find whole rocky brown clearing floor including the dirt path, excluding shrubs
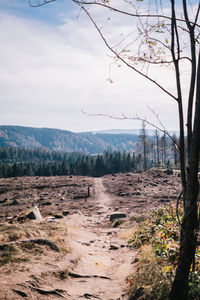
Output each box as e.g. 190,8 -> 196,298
0,170 -> 180,300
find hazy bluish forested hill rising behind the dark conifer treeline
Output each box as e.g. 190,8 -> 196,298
0,125 -> 138,154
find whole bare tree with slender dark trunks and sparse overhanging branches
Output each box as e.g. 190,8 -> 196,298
28,0 -> 200,300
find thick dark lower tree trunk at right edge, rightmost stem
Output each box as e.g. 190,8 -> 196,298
170,49 -> 200,300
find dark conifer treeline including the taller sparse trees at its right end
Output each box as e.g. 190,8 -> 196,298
0,123 -> 179,177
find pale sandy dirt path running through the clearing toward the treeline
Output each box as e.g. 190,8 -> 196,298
62,178 -> 134,300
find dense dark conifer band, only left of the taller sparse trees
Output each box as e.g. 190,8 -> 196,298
0,147 -> 143,177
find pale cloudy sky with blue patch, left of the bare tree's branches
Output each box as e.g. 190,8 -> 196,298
0,0 -> 197,132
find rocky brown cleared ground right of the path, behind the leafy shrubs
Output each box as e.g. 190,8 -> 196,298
104,168 -> 181,214
